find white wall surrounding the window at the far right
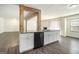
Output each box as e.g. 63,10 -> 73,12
61,15 -> 79,38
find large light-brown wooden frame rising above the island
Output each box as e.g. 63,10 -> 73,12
19,5 -> 41,32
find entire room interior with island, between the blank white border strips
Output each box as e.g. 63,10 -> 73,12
0,4 -> 79,54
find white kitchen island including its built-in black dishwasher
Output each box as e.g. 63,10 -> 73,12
19,30 -> 59,53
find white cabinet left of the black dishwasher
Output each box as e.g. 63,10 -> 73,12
19,33 -> 34,52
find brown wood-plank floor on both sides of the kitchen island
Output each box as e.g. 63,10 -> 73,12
0,32 -> 79,54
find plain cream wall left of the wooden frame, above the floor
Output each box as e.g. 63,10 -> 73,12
0,18 -> 19,33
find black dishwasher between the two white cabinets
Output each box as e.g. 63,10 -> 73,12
34,32 -> 44,49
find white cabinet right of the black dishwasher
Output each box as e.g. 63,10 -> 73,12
44,31 -> 58,45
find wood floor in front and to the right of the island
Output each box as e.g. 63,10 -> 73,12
21,37 -> 79,54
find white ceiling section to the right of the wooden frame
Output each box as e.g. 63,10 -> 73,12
26,4 -> 79,19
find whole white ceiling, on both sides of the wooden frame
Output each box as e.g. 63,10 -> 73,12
0,4 -> 79,20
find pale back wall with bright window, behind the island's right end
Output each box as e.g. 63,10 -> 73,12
41,19 -> 60,30
